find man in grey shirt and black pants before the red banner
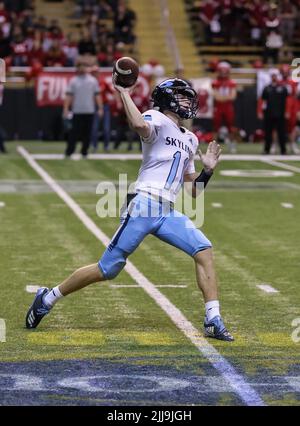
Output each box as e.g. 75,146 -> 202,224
63,61 -> 103,157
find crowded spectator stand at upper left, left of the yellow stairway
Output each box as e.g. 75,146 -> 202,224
0,0 -> 136,71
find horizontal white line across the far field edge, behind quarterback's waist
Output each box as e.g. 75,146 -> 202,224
31,154 -> 300,161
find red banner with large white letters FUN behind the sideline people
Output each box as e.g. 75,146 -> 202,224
35,71 -> 150,107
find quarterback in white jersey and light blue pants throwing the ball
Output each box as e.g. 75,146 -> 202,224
26,78 -> 233,341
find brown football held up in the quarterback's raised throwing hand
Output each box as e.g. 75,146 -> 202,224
113,56 -> 139,87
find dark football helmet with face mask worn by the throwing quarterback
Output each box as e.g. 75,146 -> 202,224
152,78 -> 198,119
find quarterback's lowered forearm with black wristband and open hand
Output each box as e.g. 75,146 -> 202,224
184,141 -> 222,198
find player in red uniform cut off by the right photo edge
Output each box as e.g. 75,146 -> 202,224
280,64 -> 300,154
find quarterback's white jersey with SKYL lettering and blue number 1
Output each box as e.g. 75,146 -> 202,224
135,109 -> 198,202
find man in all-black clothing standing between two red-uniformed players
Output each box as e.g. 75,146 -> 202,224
262,70 -> 288,155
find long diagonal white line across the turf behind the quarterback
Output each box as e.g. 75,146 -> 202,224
18,146 -> 265,406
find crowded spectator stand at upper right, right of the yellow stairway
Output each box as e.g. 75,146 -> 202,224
185,0 -> 300,75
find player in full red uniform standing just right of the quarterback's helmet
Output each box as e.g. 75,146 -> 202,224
212,62 -> 236,152
